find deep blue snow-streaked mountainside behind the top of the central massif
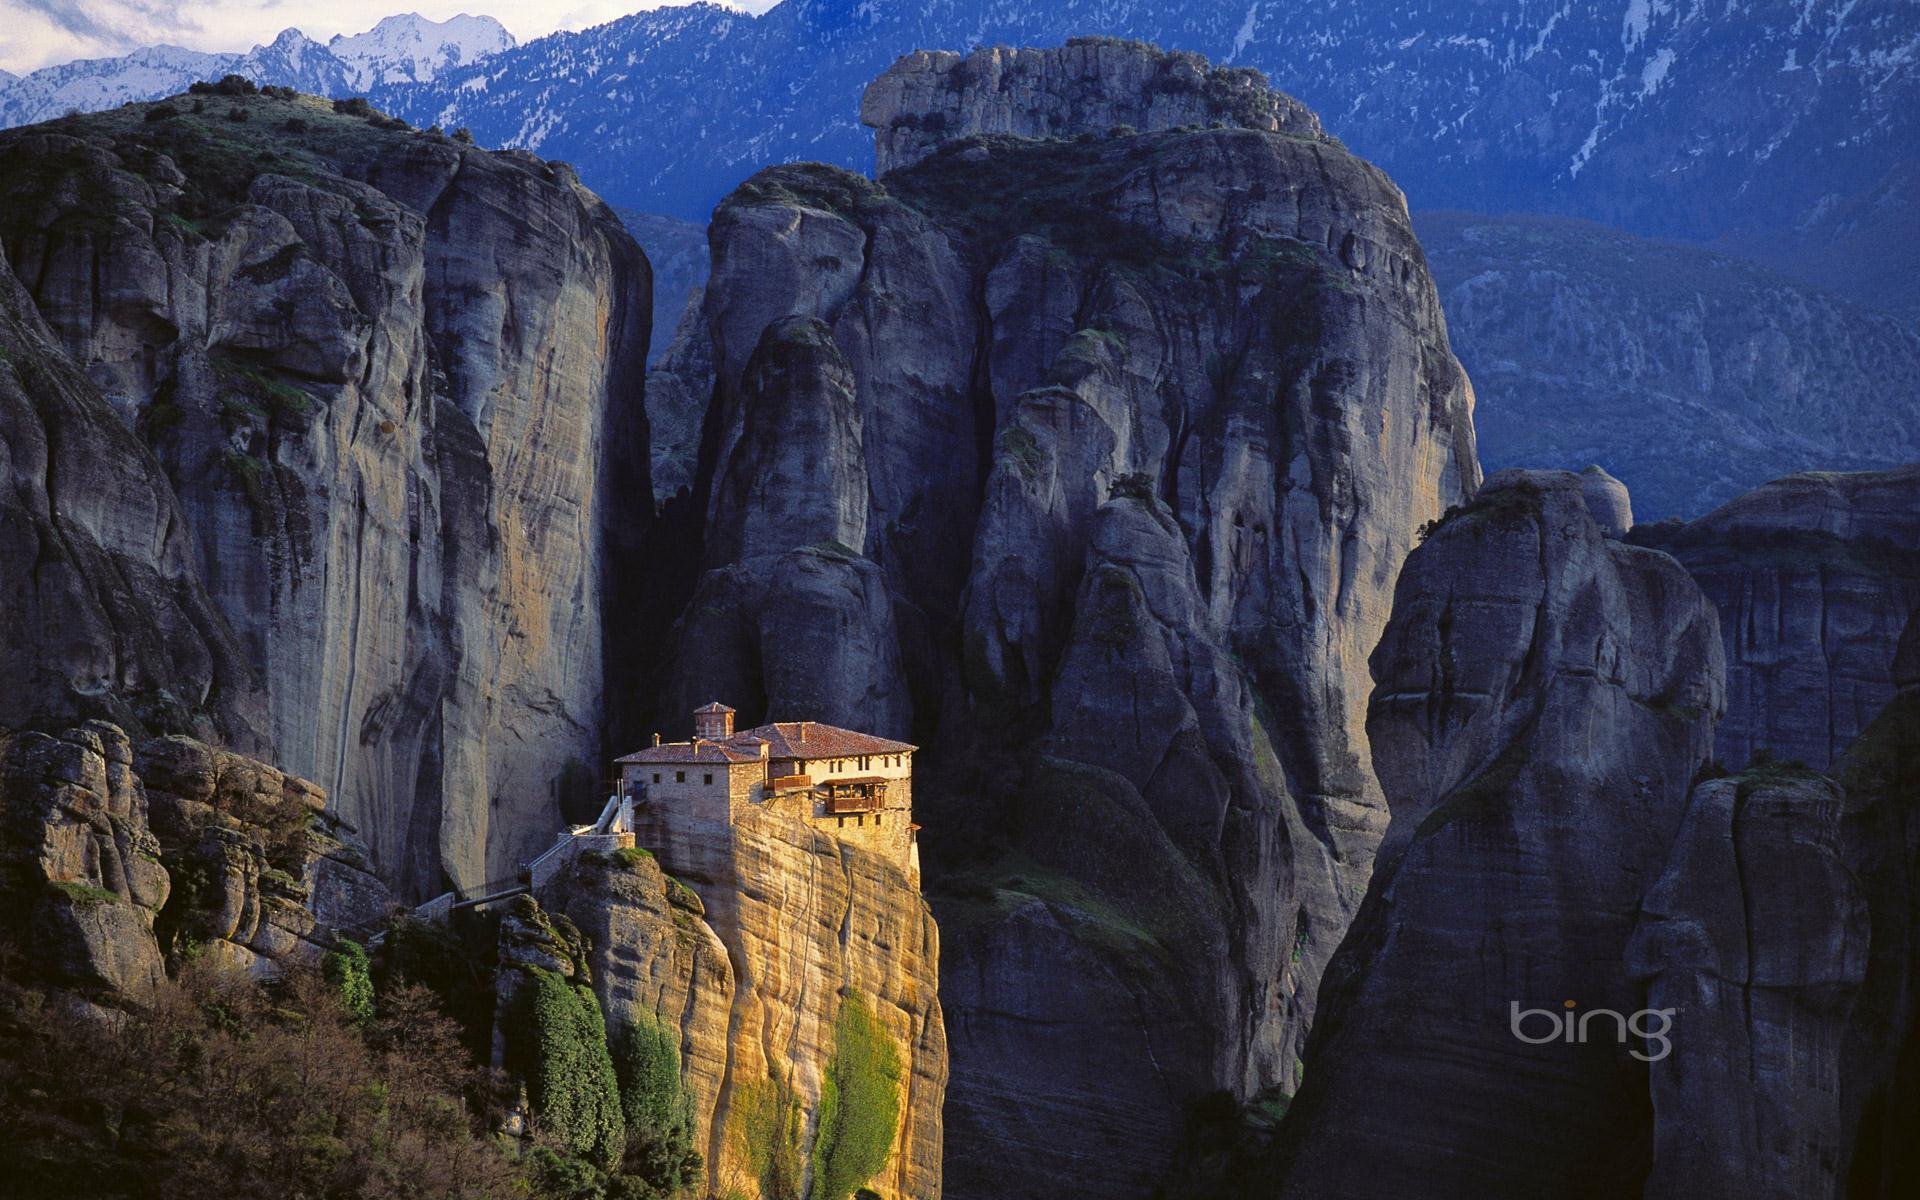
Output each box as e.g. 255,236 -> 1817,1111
376,0 -> 1920,253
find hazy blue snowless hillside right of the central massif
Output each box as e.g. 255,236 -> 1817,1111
1415,213 -> 1920,520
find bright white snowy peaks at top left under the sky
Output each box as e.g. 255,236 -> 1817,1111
0,13 -> 515,127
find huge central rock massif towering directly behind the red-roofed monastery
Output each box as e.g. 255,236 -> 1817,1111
634,42 -> 1478,1196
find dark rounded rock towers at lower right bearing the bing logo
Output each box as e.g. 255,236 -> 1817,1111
1263,472 -> 1920,1196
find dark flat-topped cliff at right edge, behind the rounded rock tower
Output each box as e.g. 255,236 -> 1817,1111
1634,467 -> 1920,770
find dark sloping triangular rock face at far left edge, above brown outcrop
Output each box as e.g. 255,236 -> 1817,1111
0,229 -> 267,747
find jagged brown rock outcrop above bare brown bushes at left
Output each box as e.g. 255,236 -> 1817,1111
0,720 -> 388,1006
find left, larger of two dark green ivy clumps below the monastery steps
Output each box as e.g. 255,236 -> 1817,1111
509,968 -> 626,1167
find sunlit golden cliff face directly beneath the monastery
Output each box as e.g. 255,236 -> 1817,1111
537,798 -> 947,1198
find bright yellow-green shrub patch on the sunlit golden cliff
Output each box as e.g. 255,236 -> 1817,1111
812,993 -> 900,1200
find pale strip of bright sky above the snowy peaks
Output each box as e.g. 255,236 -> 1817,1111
0,0 -> 776,75
